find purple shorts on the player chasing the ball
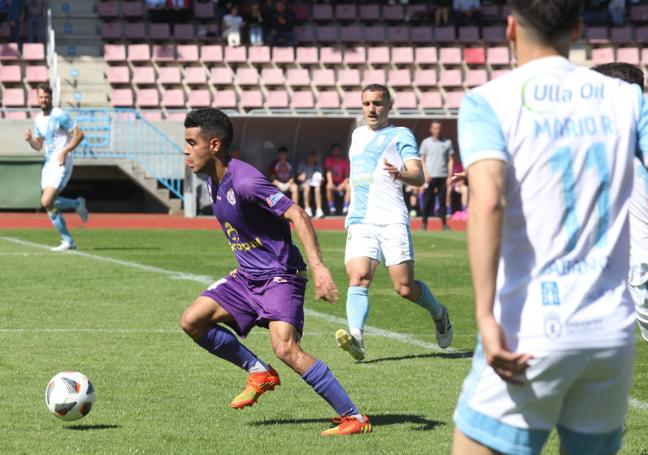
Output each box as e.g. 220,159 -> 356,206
201,272 -> 308,337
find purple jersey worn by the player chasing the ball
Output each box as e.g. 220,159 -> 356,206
207,159 -> 306,276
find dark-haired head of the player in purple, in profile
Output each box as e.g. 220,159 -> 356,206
184,107 -> 234,175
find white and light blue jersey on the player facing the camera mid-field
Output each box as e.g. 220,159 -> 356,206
346,125 -> 420,227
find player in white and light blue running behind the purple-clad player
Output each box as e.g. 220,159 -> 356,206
335,84 -> 452,360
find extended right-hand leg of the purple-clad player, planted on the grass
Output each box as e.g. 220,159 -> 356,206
269,321 -> 371,436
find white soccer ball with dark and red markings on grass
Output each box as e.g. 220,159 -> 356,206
45,371 -> 97,420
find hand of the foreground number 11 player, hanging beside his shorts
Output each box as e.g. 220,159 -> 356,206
479,317 -> 533,384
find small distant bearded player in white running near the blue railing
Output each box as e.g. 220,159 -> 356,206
25,84 -> 88,251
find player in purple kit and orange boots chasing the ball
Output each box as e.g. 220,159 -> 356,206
180,108 -> 371,436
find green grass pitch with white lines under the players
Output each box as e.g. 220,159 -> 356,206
0,229 -> 648,455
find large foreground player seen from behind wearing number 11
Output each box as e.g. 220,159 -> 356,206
452,0 -> 648,455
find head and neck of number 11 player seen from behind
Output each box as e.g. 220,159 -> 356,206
506,0 -> 584,63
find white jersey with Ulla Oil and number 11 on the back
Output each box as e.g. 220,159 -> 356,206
459,56 -> 648,355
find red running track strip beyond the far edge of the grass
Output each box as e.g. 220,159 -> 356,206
0,213 -> 466,231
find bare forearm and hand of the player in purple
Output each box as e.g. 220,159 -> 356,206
284,204 -> 338,303
